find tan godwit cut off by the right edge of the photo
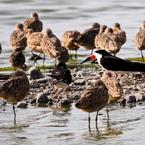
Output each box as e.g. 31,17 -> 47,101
135,22 -> 145,61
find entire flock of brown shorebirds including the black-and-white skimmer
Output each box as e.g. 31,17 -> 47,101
0,12 -> 145,130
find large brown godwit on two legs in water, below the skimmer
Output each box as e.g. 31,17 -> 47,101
75,80 -> 109,132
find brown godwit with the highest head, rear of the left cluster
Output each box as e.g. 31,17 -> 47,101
23,12 -> 43,33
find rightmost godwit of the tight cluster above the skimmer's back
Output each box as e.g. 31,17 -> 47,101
113,23 -> 127,46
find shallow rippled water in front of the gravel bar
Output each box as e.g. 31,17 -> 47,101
0,105 -> 145,145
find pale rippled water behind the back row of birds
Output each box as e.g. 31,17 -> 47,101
0,0 -> 145,66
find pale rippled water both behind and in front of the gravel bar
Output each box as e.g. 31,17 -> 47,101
0,0 -> 145,145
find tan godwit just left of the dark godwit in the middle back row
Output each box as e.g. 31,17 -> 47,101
62,31 -> 80,59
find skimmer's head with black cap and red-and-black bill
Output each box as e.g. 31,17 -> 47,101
80,50 -> 111,64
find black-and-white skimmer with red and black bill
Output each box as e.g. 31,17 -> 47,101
80,50 -> 145,72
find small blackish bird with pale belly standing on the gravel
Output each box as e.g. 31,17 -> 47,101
49,62 -> 72,98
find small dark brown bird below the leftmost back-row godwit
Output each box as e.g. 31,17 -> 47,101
10,51 -> 27,70
